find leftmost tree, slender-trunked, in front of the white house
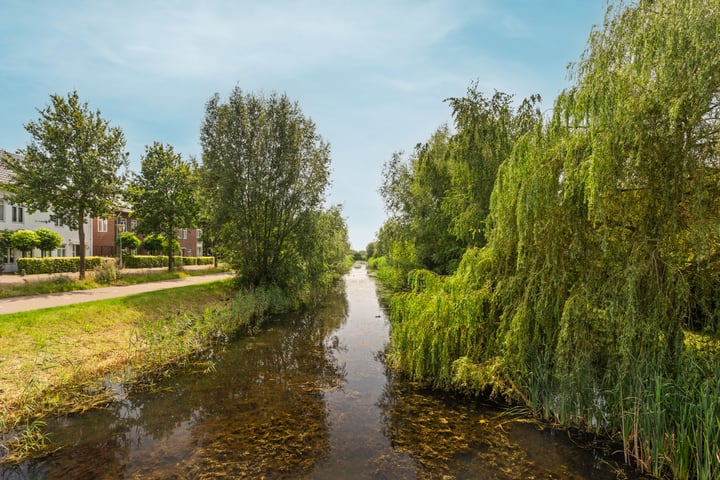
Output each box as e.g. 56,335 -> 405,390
5,91 -> 127,278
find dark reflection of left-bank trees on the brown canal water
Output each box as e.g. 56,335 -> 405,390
35,291 -> 348,478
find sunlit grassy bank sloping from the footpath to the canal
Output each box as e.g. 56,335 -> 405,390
0,281 -> 288,462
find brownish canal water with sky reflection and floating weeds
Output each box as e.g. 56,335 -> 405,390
0,265 -> 640,480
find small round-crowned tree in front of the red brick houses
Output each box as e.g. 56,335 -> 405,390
128,142 -> 199,270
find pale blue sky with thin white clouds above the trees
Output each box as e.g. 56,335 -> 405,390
0,0 -> 606,249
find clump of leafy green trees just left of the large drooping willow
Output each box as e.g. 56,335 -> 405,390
376,87 -> 542,288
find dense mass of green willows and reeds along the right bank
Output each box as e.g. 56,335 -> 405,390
371,0 -> 720,479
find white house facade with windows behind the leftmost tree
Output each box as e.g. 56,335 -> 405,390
0,150 -> 93,273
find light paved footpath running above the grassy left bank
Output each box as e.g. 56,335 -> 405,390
0,273 -> 233,315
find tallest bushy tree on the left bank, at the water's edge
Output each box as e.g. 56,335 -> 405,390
201,88 -> 330,287
